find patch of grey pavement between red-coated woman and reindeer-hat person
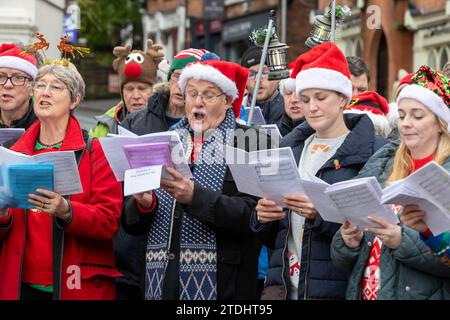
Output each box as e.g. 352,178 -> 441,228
74,99 -> 119,130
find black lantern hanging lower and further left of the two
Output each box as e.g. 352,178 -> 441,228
266,10 -> 290,80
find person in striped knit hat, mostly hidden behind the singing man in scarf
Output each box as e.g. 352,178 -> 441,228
114,48 -> 218,300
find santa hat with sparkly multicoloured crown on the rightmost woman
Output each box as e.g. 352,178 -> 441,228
397,66 -> 450,132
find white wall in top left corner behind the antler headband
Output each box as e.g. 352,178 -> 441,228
0,0 -> 65,59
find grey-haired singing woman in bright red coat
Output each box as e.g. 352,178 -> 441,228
0,64 -> 122,300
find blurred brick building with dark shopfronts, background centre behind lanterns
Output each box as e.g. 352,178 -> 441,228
143,0 -> 317,62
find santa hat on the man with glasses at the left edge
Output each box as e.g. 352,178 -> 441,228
0,43 -> 38,80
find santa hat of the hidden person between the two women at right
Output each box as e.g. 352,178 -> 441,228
344,91 -> 392,137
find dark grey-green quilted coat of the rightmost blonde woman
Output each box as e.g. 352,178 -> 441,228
331,142 -> 450,300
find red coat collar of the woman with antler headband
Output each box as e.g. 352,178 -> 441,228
11,115 -> 86,155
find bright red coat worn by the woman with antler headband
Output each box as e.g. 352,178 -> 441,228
0,117 -> 122,300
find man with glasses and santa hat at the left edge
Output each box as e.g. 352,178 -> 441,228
0,43 -> 37,129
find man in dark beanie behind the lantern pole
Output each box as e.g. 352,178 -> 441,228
241,47 -> 284,124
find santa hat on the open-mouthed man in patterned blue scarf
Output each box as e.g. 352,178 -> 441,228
178,60 -> 248,118
